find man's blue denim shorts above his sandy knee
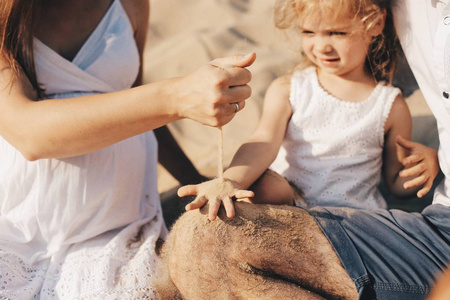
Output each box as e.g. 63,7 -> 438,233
309,204 -> 450,300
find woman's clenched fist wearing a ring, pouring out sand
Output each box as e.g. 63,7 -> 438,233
174,53 -> 256,127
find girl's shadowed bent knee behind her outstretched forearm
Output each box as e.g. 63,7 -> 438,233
250,169 -> 300,205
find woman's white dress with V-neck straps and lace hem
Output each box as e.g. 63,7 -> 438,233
0,0 -> 167,299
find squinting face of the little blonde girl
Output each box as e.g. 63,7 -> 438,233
300,13 -> 371,77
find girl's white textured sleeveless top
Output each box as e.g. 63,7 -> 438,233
271,67 -> 400,209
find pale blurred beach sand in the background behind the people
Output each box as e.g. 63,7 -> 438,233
144,0 -> 438,224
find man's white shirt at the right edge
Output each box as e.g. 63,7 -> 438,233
393,0 -> 450,206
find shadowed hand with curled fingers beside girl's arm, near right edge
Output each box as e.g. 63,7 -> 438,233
396,136 -> 439,198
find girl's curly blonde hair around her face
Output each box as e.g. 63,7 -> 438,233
274,0 -> 400,83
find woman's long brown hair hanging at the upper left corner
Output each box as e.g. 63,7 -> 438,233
0,0 -> 43,98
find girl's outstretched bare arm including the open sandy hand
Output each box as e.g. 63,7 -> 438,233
178,76 -> 292,220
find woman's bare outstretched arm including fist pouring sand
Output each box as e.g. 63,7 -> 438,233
0,54 -> 255,160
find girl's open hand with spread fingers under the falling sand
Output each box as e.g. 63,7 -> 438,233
178,178 -> 254,221
